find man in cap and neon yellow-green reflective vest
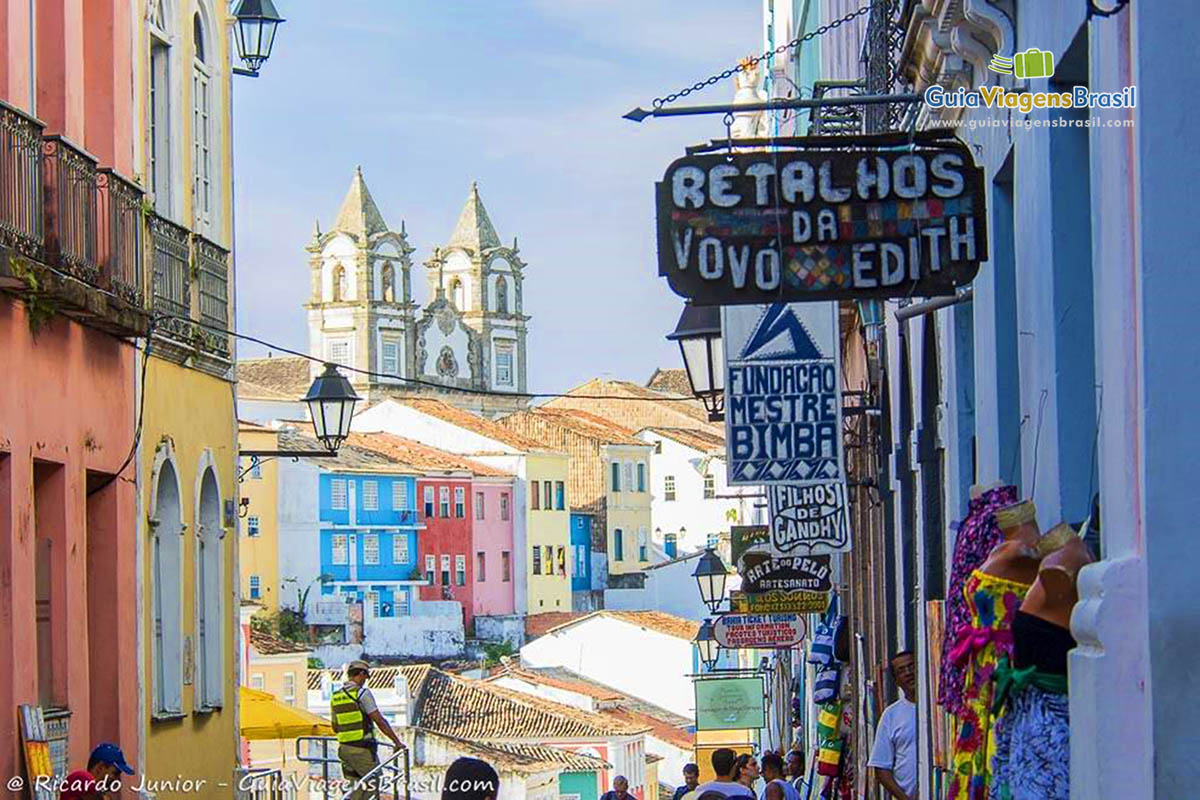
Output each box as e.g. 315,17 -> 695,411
330,661 -> 400,800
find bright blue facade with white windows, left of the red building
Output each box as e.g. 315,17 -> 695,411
318,471 -> 422,616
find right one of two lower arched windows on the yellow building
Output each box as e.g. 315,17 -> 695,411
196,467 -> 224,709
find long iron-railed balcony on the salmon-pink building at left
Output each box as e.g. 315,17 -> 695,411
0,103 -> 150,338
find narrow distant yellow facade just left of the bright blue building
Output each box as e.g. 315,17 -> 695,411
238,423 -> 280,609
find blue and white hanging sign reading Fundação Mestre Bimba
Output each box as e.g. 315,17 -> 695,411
721,302 -> 845,486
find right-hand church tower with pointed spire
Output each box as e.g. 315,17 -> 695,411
418,182 -> 529,400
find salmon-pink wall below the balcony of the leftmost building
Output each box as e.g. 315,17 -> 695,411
0,297 -> 142,775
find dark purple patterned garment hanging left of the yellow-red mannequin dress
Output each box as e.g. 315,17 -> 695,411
937,486 -> 1016,714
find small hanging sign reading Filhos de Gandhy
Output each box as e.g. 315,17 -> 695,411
767,481 -> 850,555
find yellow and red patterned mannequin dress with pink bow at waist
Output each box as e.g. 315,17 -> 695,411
947,570 -> 1030,800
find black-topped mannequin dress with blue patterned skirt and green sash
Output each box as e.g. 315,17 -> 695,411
991,610 -> 1075,800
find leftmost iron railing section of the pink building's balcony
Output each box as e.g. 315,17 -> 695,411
0,101 -> 43,258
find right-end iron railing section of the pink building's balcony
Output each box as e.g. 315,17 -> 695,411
96,169 -> 145,306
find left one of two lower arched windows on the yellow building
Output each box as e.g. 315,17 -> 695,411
150,461 -> 184,716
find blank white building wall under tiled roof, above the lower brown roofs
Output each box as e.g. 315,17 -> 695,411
521,614 -> 695,718
